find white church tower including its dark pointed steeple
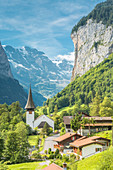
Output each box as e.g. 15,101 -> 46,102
25,85 -> 35,129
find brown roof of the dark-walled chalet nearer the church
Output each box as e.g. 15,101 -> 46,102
54,132 -> 82,142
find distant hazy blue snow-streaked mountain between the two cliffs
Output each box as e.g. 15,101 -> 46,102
3,45 -> 73,104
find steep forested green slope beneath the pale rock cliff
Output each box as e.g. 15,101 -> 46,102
49,54 -> 113,108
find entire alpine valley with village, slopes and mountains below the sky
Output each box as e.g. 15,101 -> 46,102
0,0 -> 113,170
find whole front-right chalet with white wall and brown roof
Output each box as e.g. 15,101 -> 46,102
70,136 -> 110,158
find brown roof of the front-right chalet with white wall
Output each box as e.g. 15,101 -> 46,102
70,136 -> 110,148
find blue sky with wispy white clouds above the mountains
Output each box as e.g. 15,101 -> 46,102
0,0 -> 104,59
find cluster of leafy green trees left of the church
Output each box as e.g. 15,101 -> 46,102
0,102 -> 31,163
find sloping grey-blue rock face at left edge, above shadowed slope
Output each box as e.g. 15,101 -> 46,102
0,43 -> 13,78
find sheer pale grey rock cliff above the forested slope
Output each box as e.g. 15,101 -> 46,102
71,19 -> 113,81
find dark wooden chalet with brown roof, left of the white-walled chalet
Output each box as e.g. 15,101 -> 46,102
54,132 -> 82,153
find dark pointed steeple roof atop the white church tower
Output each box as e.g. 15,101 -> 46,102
25,85 -> 35,109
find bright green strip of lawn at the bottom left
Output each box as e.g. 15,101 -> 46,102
8,162 -> 47,170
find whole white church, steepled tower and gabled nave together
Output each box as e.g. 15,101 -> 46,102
25,86 -> 54,132
